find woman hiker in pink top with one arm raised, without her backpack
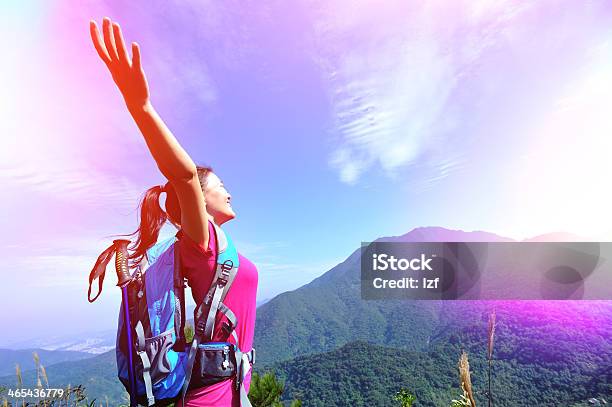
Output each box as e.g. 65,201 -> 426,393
90,18 -> 258,407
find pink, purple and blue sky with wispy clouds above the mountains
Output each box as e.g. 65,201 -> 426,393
0,0 -> 612,340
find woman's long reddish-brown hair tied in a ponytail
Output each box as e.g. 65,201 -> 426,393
127,166 -> 213,268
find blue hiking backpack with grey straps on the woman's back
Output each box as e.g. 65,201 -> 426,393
88,223 -> 255,407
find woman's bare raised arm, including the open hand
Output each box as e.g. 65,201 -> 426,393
90,18 -> 208,247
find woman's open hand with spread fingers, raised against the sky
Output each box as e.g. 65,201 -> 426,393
89,17 -> 149,108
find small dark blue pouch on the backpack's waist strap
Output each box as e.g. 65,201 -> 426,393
190,342 -> 236,387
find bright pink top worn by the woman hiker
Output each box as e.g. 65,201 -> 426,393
176,221 -> 258,407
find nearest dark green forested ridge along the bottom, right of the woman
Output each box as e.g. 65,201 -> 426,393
266,341 -> 612,407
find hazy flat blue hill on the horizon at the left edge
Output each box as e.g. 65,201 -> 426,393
0,349 -> 92,376
